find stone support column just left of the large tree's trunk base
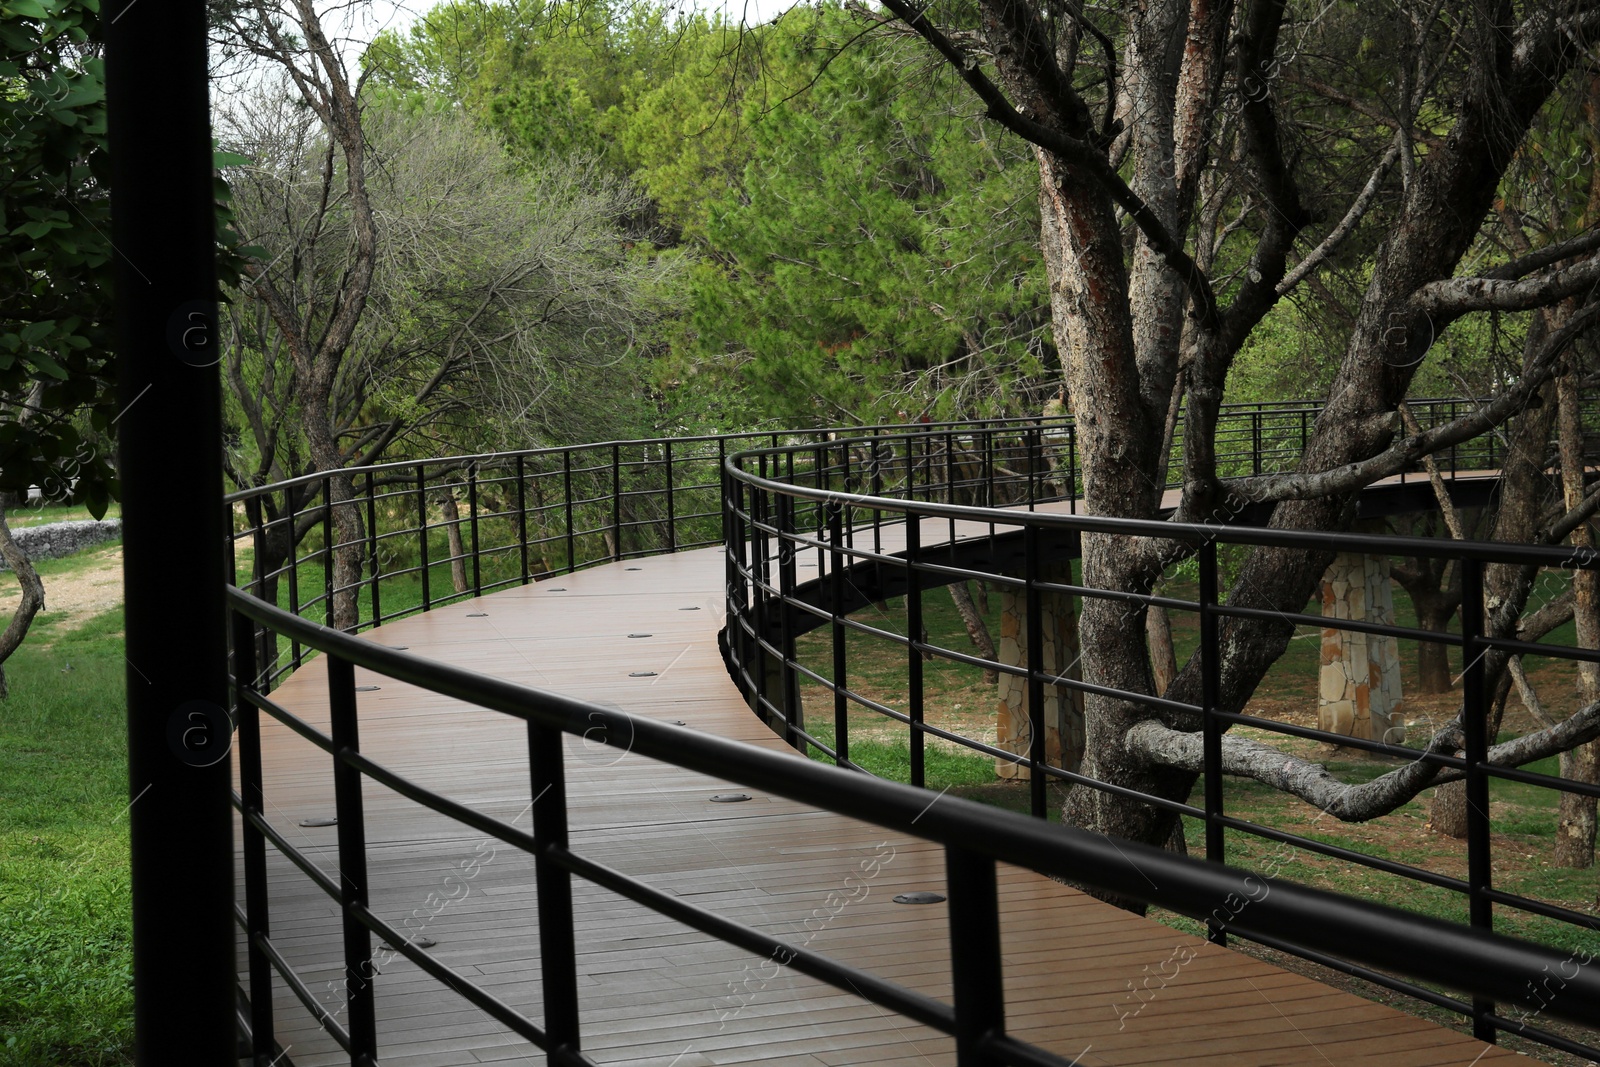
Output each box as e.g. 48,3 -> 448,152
995,565 -> 1083,781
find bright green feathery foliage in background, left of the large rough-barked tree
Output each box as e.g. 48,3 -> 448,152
627,8 -> 1056,422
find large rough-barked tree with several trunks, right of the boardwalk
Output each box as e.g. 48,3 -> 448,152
861,0 -> 1600,876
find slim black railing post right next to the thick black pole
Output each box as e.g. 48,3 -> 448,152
234,611 -> 274,1067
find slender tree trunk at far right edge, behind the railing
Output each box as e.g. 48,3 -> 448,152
1555,365 -> 1600,869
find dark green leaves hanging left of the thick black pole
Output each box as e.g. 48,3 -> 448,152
0,0 -> 115,514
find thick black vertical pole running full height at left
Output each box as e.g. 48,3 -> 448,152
104,0 -> 238,1067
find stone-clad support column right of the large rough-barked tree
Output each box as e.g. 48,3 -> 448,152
1317,552 -> 1405,744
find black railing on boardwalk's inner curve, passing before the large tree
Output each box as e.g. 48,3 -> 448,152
723,422 -> 1600,1057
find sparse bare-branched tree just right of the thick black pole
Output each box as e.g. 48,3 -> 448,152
214,3 -> 674,629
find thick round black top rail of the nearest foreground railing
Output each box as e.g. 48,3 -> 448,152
224,589 -> 1600,1025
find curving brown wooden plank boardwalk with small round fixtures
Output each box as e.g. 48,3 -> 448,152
240,508 -> 1533,1067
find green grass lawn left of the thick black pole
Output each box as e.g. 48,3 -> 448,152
0,604 -> 133,1067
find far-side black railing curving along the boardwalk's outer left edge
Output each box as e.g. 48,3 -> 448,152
227,400 -> 1523,694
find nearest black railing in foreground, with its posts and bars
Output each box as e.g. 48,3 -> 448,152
227,589 -> 1600,1067
